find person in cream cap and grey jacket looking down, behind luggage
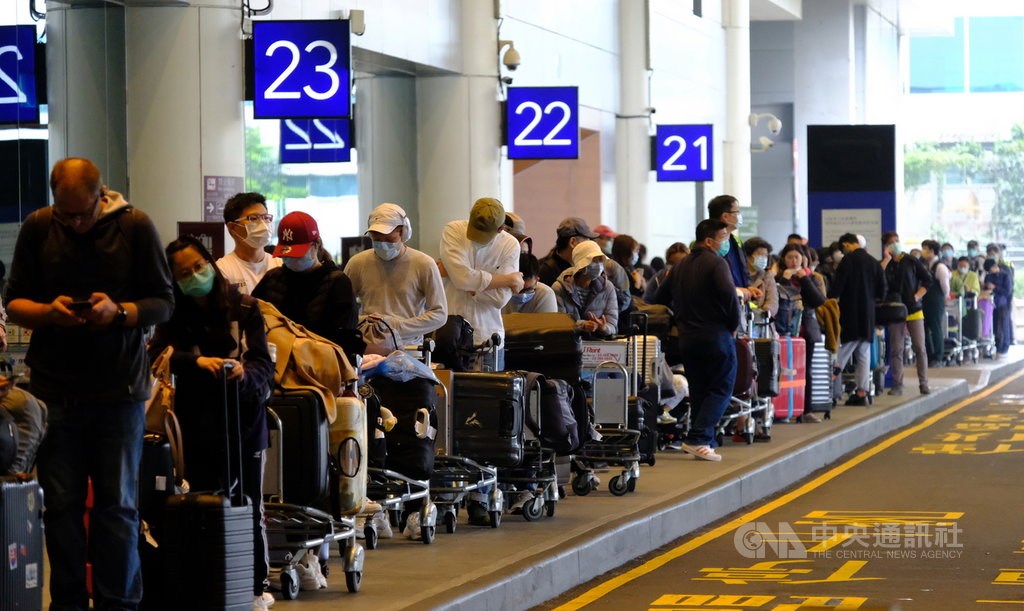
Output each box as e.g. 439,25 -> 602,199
551,241 -> 618,338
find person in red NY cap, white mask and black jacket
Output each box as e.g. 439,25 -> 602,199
253,212 -> 365,357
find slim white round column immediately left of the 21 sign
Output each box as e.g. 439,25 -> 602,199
614,1 -> 651,242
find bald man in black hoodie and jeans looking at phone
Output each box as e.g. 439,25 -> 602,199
7,158 -> 174,609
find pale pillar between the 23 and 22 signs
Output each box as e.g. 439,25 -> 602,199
416,1 -> 499,255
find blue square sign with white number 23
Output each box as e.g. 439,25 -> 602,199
253,19 -> 351,119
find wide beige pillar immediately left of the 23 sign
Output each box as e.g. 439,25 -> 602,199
125,0 -> 246,241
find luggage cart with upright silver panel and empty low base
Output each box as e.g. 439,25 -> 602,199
572,336 -> 644,496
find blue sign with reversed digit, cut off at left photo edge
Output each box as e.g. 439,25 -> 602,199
0,26 -> 39,123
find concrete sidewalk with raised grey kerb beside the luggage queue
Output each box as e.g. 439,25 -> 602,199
275,347 -> 1024,611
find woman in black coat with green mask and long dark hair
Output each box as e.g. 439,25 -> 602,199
150,237 -> 273,599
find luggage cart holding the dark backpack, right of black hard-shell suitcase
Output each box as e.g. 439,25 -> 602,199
498,384 -> 558,522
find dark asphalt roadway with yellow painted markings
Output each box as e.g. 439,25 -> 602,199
541,364 -> 1024,611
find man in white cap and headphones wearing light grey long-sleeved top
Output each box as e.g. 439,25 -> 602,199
345,204 -> 447,348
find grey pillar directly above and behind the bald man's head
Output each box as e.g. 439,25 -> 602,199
46,4 -> 128,191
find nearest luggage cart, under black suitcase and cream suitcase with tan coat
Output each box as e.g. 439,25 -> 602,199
263,407 -> 365,600
